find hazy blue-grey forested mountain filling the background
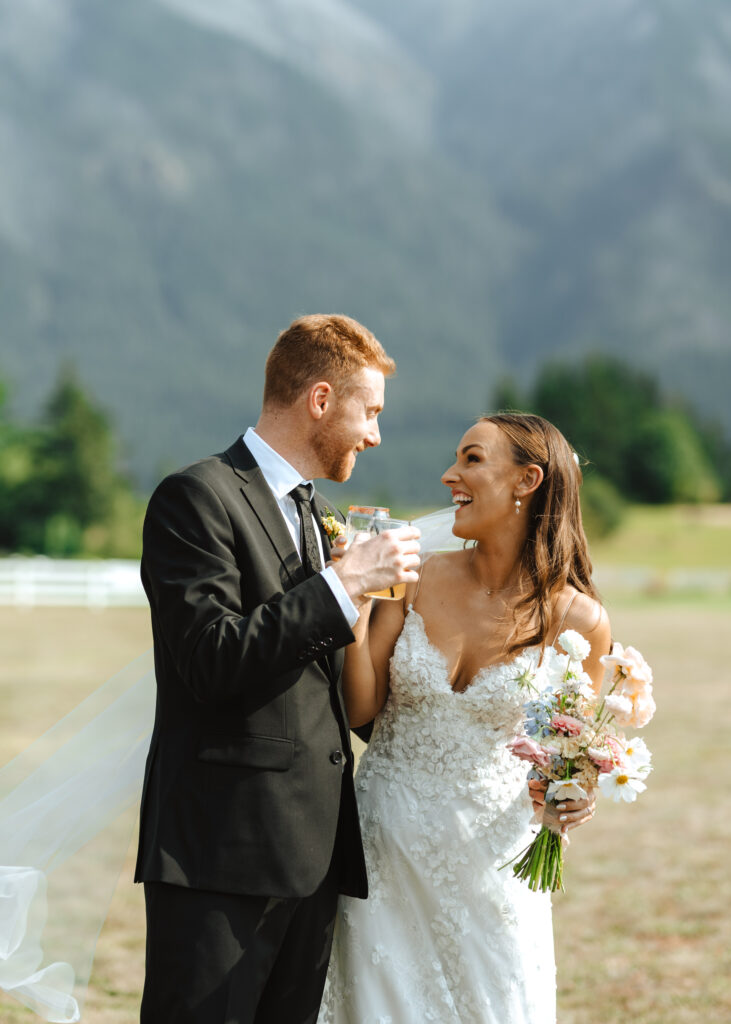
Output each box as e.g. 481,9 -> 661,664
0,0 -> 731,503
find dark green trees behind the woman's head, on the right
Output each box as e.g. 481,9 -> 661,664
492,354 -> 731,535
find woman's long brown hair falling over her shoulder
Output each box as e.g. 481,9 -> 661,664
480,413 -> 598,653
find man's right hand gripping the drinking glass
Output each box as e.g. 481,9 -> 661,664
333,526 -> 421,606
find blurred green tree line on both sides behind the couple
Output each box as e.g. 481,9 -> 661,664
0,355 -> 731,557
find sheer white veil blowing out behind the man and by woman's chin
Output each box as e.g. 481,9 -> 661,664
0,508 -> 454,1024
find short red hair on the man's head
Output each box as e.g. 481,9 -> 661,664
264,313 -> 396,406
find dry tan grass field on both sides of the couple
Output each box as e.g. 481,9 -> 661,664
0,598 -> 731,1024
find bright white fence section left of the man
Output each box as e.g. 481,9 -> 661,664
0,556 -> 147,608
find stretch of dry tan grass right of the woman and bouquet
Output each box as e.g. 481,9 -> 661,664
554,603 -> 731,1024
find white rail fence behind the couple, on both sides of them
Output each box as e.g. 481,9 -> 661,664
0,556 -> 731,608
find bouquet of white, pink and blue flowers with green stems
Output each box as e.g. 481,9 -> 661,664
505,630 -> 655,892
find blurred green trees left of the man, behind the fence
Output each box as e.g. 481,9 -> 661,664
0,367 -> 143,558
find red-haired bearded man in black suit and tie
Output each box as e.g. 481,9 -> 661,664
135,315 -> 419,1024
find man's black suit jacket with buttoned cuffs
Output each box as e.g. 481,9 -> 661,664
135,440 -> 367,896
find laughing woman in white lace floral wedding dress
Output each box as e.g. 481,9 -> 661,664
318,414 -> 610,1024
